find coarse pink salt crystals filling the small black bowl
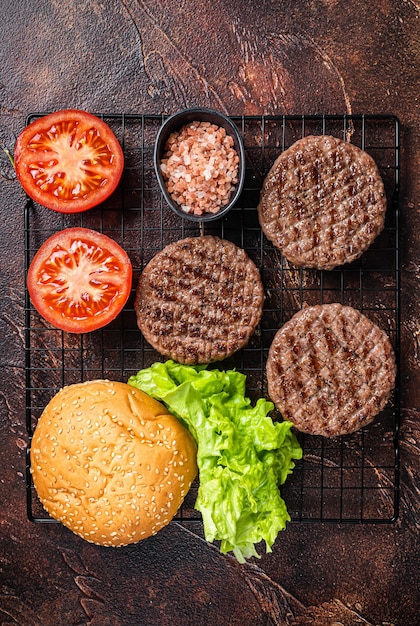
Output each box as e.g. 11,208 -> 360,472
160,122 -> 239,215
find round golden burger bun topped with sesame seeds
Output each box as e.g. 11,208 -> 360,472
30,380 -> 197,546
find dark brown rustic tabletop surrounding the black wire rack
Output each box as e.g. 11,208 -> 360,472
0,0 -> 420,626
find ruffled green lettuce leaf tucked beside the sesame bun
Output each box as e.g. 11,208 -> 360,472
128,361 -> 302,562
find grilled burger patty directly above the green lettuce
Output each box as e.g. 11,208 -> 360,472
134,235 -> 264,365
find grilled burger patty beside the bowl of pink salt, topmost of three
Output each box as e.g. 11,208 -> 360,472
258,135 -> 386,270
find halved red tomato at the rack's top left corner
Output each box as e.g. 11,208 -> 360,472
14,109 -> 124,213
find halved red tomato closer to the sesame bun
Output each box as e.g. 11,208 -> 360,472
27,228 -> 132,333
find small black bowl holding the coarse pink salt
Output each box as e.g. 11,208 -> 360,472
154,108 -> 245,222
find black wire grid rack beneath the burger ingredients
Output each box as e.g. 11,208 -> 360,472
25,113 -> 400,523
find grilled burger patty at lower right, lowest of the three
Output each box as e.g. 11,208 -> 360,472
267,304 -> 396,437
